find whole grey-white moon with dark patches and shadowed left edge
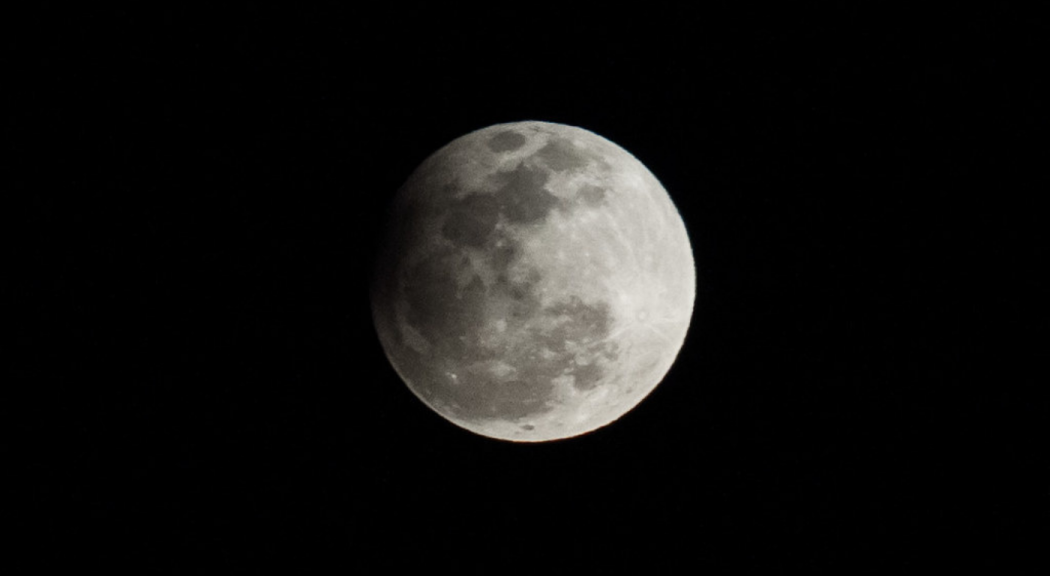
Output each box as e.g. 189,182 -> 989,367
372,122 -> 696,442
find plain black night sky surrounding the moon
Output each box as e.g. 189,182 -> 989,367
2,3 -> 1050,574
